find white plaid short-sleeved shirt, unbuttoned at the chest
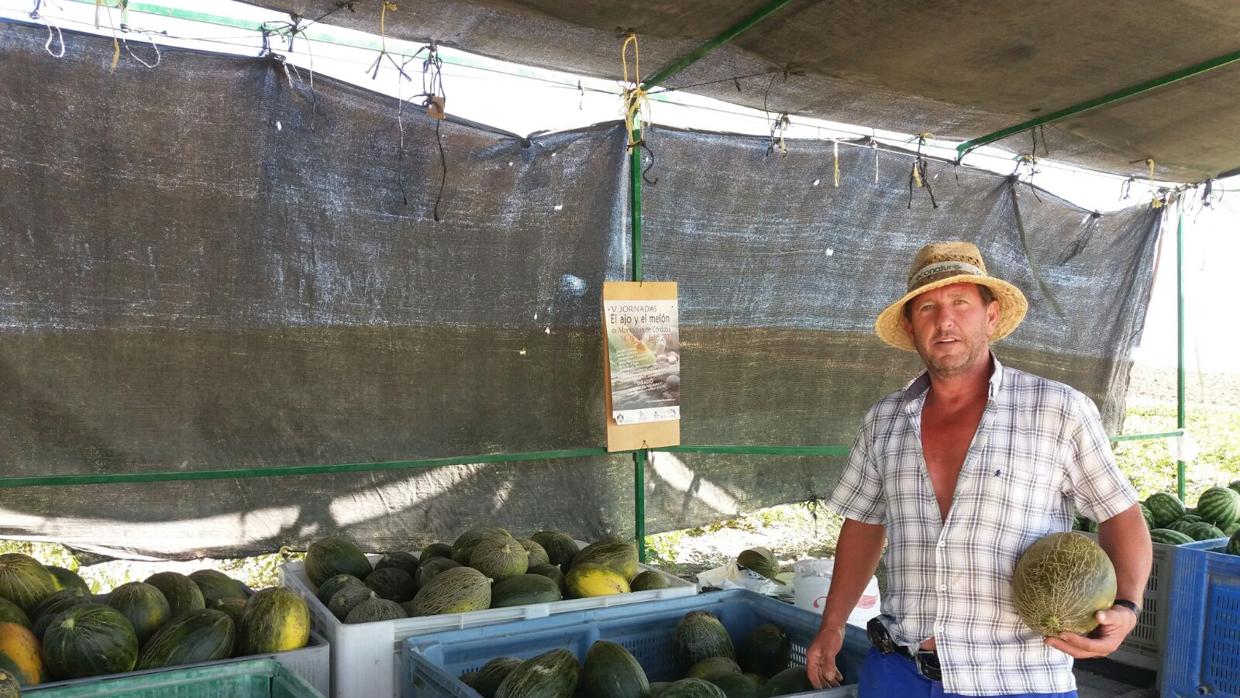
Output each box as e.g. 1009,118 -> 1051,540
828,356 -> 1137,696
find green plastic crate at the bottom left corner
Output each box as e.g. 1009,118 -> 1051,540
26,660 -> 324,698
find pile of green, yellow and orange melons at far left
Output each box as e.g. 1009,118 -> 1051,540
0,553 -> 310,686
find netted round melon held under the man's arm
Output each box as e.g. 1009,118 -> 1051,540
1012,532 -> 1115,637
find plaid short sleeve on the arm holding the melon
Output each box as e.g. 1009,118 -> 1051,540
1065,393 -> 1137,521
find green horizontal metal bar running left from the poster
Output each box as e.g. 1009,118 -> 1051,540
0,449 -> 618,488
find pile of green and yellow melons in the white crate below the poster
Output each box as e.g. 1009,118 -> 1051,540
305,528 -> 671,622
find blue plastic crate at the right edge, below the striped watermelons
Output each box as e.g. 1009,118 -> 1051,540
1162,539 -> 1240,698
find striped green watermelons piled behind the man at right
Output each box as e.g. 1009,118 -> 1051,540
1074,480 -> 1240,550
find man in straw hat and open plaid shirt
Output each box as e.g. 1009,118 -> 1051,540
807,242 -> 1152,698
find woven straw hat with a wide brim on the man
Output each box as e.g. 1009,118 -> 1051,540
874,242 -> 1029,351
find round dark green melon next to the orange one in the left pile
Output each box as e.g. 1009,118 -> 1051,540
41,604 -> 138,681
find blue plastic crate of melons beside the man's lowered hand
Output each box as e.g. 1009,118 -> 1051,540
401,589 -> 869,698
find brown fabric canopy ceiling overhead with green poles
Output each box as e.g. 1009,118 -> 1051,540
244,0 -> 1240,182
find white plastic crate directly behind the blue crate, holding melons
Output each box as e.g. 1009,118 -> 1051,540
280,555 -> 697,698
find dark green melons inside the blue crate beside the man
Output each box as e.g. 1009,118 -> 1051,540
460,611 -> 813,698
